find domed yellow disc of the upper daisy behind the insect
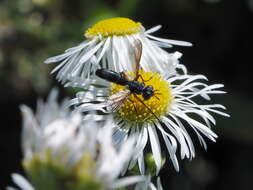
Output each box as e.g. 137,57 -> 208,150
85,17 -> 141,38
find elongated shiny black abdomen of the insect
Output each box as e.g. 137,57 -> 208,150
96,69 -> 128,85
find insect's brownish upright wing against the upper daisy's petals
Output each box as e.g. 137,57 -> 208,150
133,39 -> 142,80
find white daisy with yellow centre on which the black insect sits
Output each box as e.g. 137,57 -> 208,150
69,70 -> 229,174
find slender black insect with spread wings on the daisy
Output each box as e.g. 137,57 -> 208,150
96,40 -> 159,120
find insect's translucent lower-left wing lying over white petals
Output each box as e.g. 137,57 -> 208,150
107,89 -> 131,112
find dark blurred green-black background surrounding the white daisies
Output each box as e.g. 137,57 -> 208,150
0,0 -> 253,190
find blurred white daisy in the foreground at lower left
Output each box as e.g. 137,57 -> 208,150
7,90 -> 145,190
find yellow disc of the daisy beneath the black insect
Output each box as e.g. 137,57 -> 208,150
110,70 -> 173,125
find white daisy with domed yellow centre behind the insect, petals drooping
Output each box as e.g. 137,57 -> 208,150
45,17 -> 191,83
